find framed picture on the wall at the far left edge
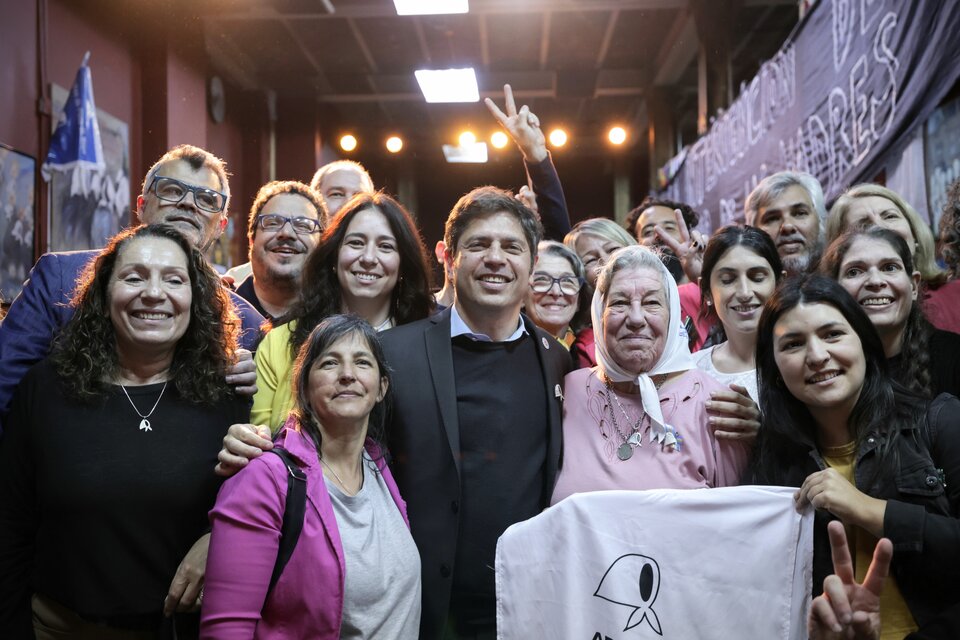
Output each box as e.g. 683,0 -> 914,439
0,143 -> 37,303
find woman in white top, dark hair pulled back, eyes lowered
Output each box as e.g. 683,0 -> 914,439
693,225 -> 783,402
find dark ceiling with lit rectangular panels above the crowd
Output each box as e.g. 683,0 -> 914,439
201,0 -> 798,162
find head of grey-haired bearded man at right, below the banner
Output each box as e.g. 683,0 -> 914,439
743,171 -> 827,276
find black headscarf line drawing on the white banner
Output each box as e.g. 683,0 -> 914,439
593,553 -> 663,636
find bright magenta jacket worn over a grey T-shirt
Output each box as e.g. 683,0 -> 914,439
200,420 -> 410,640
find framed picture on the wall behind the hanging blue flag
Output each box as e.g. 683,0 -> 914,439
48,84 -> 133,251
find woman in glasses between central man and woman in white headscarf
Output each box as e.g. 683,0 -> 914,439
524,240 -> 589,349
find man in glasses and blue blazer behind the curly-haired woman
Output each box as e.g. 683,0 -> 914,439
0,145 -> 263,428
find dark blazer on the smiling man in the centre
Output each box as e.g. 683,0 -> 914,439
383,309 -> 571,640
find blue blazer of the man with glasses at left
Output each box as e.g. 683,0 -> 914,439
0,251 -> 263,432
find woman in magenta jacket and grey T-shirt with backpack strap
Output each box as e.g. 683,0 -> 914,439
201,316 -> 420,639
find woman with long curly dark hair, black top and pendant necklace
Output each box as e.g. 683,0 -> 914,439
0,225 -> 249,638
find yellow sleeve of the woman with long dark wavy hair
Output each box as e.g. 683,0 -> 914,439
250,322 -> 296,433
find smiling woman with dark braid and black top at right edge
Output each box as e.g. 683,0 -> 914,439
820,227 -> 960,398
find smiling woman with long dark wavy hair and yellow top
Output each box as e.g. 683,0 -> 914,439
251,193 -> 434,431
